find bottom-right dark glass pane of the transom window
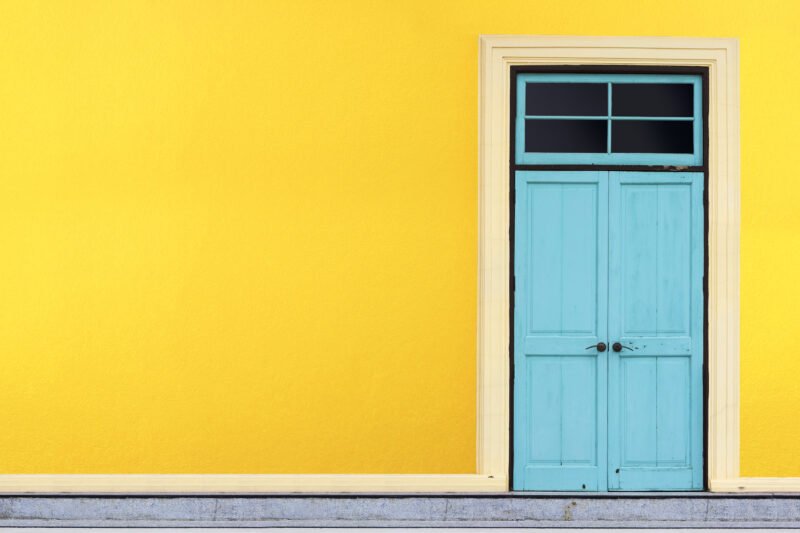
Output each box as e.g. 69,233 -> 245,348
611,120 -> 694,154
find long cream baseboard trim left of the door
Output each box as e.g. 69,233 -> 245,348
0,474 -> 507,494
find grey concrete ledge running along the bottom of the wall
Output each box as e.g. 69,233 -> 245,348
0,493 -> 800,528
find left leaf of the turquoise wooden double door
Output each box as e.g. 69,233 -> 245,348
514,172 -> 608,490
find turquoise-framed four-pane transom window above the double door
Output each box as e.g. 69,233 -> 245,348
515,74 -> 703,166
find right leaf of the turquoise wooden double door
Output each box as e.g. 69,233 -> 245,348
608,172 -> 704,490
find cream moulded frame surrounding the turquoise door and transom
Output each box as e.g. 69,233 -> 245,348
477,35 -> 739,490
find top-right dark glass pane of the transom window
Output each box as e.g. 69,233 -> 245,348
611,83 -> 694,117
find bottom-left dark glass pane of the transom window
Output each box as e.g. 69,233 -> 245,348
525,120 -> 608,153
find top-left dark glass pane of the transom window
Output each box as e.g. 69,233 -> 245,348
525,83 -> 608,117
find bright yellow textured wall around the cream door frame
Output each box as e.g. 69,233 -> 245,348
0,0 -> 800,476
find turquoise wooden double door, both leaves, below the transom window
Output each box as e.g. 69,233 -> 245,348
513,171 -> 704,491
